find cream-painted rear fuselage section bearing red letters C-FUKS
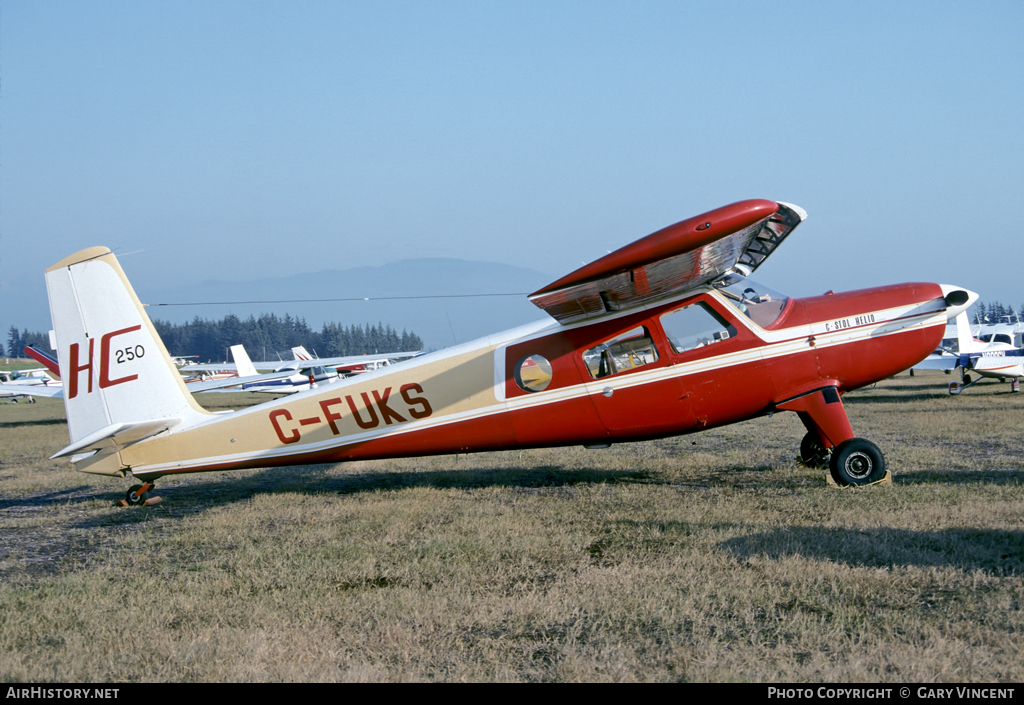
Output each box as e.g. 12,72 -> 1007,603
121,332 -> 516,478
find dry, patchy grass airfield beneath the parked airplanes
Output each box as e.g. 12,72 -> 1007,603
0,374 -> 1024,682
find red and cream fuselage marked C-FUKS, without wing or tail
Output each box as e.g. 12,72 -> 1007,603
92,284 -> 946,479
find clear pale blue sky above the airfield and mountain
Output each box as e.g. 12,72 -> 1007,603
0,0 -> 1024,330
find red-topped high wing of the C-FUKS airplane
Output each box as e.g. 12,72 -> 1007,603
529,200 -> 807,324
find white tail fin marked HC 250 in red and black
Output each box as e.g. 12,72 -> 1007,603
46,247 -> 210,471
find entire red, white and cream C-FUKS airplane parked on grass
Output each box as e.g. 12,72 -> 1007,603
39,200 -> 972,504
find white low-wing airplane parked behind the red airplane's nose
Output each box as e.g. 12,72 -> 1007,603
914,312 -> 1024,395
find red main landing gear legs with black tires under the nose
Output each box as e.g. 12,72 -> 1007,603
775,386 -> 889,487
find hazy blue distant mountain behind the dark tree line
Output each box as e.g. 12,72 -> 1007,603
133,258 -> 555,356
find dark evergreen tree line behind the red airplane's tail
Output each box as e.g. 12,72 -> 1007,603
0,314 -> 423,362
